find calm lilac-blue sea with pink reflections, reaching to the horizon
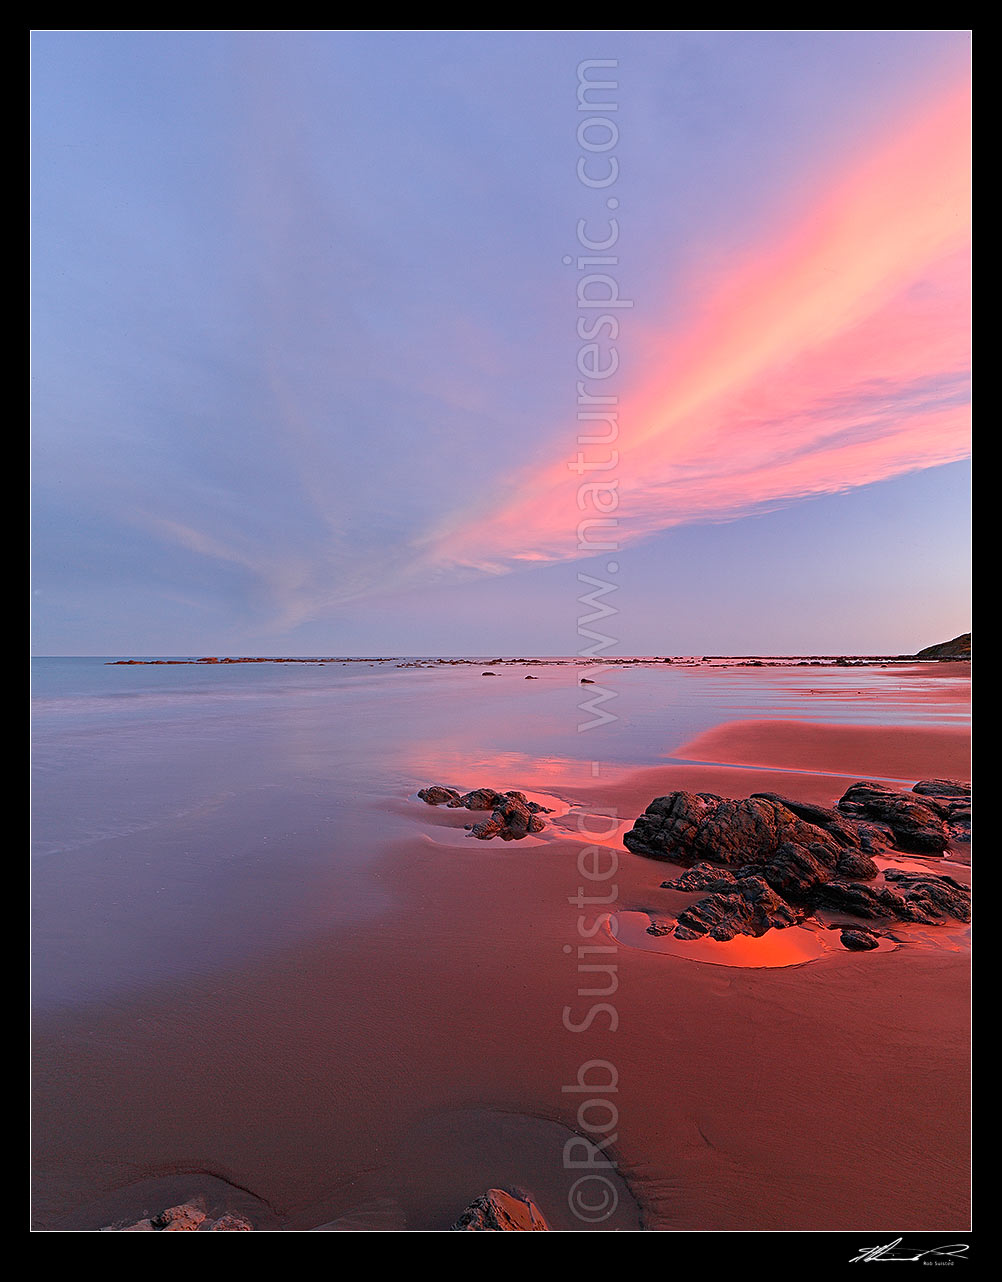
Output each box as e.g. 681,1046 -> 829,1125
32,658 -> 966,1006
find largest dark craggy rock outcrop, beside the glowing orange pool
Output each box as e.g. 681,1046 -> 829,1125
635,779 -> 970,951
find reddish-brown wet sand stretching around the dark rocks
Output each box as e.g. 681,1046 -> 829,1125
35,720 -> 969,1231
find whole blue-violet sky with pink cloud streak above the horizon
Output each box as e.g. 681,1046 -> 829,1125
32,31 -> 970,656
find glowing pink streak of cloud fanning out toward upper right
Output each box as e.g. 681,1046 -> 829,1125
422,80 -> 970,570
